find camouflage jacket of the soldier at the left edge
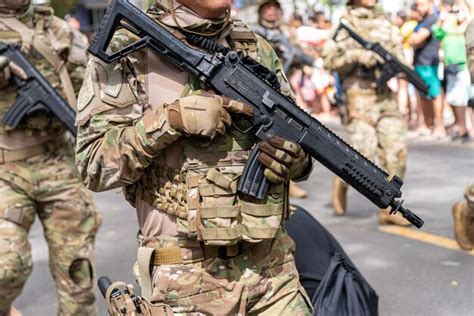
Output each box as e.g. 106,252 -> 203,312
0,7 -> 87,150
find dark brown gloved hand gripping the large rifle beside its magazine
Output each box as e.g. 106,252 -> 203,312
258,136 -> 309,184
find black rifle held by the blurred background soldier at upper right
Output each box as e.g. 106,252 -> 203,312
333,20 -> 428,95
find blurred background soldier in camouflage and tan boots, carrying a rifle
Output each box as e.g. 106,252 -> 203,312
323,0 -> 409,226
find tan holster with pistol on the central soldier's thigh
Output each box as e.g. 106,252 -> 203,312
97,277 -> 173,316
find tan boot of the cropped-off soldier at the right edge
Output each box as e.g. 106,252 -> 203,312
452,184 -> 474,250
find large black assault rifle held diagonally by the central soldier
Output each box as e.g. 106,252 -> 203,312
89,0 -> 423,228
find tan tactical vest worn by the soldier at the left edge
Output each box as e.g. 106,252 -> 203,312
0,7 -> 76,134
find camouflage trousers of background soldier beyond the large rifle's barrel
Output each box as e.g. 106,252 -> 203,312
348,95 -> 408,178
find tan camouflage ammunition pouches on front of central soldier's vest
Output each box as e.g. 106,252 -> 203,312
182,168 -> 286,246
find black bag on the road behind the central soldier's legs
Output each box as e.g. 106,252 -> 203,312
286,207 -> 378,316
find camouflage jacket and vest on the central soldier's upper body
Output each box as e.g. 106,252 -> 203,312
76,1 -> 304,246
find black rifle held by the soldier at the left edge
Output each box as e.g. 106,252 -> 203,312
0,42 -> 77,137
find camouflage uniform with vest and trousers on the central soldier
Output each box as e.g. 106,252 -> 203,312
76,0 -> 311,315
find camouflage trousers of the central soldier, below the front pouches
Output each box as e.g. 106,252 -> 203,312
146,230 -> 312,315
